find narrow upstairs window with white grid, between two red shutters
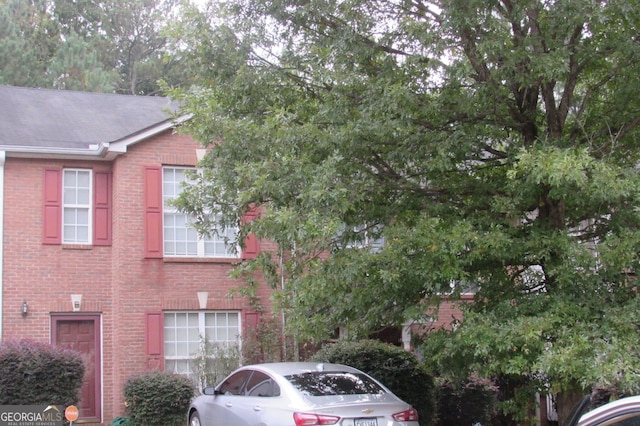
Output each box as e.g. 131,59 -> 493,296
62,169 -> 92,244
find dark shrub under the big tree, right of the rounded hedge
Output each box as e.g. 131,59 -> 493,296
436,374 -> 498,426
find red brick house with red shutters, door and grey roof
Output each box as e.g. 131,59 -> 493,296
0,86 -> 270,424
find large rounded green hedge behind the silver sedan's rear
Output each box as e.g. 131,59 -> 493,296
312,340 -> 436,426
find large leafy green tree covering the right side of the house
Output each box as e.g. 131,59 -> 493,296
166,0 -> 640,420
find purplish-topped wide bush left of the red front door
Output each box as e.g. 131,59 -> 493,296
0,339 -> 85,406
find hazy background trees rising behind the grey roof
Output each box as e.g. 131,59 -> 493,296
0,0 -> 188,95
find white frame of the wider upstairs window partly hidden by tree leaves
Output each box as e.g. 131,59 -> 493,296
162,166 -> 240,259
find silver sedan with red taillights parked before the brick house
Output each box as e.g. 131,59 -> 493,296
188,362 -> 418,426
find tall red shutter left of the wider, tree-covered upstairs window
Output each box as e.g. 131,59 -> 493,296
144,166 -> 163,259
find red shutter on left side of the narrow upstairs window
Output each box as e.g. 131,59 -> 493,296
42,169 -> 62,244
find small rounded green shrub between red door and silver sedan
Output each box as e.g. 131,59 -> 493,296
124,371 -> 195,426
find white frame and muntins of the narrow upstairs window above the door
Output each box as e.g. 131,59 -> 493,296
61,168 -> 93,245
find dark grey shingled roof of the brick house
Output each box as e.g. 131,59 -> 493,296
0,86 -> 188,160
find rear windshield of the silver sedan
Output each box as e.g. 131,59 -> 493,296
285,371 -> 385,396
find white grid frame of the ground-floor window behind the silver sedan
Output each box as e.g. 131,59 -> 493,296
163,310 -> 242,380
